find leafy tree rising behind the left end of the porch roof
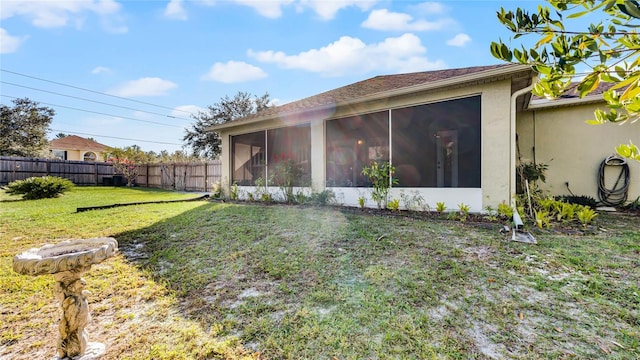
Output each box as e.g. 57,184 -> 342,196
183,92 -> 271,158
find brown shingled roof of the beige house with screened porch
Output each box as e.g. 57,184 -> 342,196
208,64 -> 531,130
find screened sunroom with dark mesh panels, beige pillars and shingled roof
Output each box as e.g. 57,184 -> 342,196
210,65 -> 531,211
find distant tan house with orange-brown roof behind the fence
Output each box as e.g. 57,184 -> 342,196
49,135 -> 109,162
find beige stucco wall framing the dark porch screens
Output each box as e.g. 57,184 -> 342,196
221,79 -> 511,211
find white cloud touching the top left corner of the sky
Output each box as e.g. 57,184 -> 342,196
0,0 -> 122,30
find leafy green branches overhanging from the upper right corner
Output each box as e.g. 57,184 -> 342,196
491,0 -> 640,160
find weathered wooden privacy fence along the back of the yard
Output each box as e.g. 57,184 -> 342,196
0,156 -> 222,191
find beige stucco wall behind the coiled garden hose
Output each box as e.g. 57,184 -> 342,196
517,103 -> 640,201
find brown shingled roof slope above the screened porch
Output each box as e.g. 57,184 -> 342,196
211,64 -> 528,130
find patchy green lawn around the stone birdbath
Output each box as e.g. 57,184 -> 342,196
0,188 -> 640,359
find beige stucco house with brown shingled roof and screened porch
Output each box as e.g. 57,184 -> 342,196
208,64 -> 640,212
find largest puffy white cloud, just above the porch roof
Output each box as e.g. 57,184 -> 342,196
248,34 -> 445,76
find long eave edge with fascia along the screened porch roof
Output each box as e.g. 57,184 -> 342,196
205,64 -> 533,131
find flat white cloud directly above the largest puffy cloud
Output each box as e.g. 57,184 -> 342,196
362,9 -> 454,31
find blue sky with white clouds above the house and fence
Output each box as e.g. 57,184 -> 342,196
0,0 -> 543,152
